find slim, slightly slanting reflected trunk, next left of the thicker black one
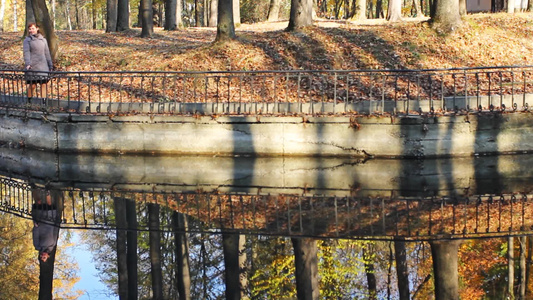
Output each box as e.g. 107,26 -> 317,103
172,212 -> 191,300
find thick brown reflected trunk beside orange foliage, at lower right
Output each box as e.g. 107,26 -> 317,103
429,240 -> 461,300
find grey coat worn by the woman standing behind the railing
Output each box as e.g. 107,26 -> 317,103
22,33 -> 52,80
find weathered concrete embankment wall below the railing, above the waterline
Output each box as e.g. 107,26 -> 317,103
0,110 -> 533,157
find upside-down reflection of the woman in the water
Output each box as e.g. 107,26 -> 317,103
32,190 -> 59,262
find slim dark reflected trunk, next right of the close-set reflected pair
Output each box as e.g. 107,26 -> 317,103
148,203 -> 163,299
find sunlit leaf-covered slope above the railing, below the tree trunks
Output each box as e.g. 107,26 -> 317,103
0,13 -> 533,71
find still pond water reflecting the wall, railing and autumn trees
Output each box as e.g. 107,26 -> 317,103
0,149 -> 533,299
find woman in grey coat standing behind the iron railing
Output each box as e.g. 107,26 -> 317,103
22,23 -> 53,98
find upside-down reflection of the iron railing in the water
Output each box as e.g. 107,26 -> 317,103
0,178 -> 533,240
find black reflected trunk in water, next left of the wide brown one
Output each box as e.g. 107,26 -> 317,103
222,233 -> 241,300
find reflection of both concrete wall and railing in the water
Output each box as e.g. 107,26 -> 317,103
1,150 -> 533,240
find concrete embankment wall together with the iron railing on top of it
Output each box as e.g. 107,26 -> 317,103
0,67 -> 533,157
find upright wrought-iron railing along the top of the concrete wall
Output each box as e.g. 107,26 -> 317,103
0,66 -> 533,114
